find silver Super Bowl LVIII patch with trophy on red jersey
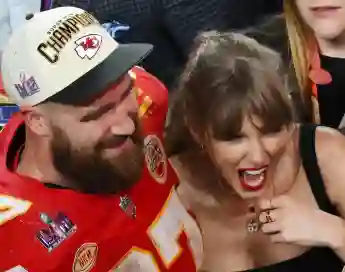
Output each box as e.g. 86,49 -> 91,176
37,212 -> 77,252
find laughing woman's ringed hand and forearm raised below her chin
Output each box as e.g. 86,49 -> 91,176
259,196 -> 345,248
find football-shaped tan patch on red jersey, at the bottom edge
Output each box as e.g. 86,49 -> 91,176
73,243 -> 98,272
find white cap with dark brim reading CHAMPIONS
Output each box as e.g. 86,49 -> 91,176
1,7 -> 153,106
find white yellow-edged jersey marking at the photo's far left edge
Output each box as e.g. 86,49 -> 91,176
0,195 -> 32,226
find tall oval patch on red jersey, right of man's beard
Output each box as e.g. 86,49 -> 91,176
144,135 -> 167,184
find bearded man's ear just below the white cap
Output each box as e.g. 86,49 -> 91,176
22,107 -> 51,137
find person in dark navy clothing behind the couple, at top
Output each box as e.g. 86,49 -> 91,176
52,0 -> 280,89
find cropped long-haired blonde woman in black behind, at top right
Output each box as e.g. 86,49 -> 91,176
247,0 -> 345,128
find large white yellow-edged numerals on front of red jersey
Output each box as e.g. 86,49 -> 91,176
112,190 -> 202,272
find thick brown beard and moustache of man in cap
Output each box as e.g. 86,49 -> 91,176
51,120 -> 145,194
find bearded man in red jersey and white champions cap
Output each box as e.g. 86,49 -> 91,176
0,7 -> 201,272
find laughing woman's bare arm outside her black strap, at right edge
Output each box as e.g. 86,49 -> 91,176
316,127 -> 345,262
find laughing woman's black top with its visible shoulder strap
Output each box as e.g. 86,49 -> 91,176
243,125 -> 344,272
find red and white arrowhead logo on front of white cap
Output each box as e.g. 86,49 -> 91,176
75,34 -> 102,59
